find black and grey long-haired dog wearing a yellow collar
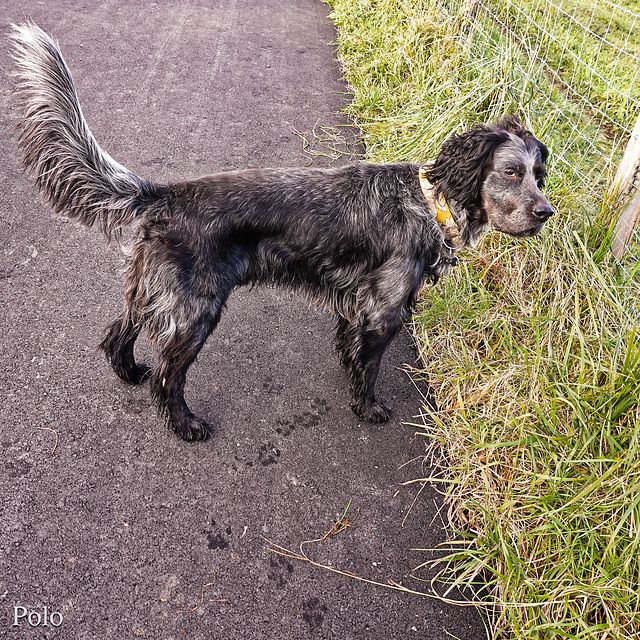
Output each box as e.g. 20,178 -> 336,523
12,23 -> 553,441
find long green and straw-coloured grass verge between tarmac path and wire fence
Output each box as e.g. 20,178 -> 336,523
330,0 -> 640,640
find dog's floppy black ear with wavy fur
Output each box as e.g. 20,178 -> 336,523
426,126 -> 509,209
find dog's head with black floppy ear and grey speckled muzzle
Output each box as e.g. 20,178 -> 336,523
428,117 -> 553,242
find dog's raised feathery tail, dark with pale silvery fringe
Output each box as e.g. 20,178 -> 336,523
12,23 -> 165,239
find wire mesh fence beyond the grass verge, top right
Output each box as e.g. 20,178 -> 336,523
448,0 -> 640,257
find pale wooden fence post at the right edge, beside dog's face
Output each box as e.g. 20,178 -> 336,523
609,115 -> 640,259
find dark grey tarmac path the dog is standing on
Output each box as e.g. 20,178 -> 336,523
0,0 -> 485,640
